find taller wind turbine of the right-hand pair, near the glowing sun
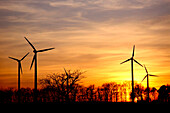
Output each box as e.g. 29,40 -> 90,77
120,45 -> 143,102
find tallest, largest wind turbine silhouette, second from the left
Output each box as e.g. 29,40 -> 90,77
24,37 -> 54,102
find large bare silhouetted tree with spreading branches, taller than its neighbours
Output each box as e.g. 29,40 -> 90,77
40,70 -> 84,102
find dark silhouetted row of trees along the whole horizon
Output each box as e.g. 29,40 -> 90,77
0,70 -> 170,103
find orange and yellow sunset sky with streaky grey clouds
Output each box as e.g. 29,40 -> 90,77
0,0 -> 170,88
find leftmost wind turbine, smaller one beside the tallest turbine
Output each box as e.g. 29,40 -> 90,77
9,52 -> 29,103
